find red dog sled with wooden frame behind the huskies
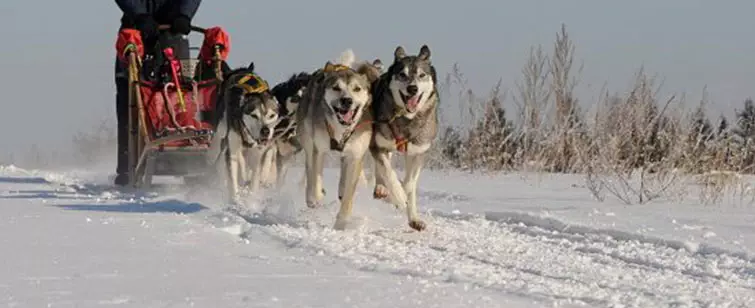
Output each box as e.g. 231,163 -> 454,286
116,26 -> 230,188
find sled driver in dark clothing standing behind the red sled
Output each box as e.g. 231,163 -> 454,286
115,0 -> 202,186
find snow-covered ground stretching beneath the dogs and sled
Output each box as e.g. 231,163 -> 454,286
0,162 -> 755,307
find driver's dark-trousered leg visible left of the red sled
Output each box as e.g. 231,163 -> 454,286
115,59 -> 129,186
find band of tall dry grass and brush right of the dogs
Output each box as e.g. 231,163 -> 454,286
436,23 -> 755,204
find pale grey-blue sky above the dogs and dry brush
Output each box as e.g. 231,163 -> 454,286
0,0 -> 755,158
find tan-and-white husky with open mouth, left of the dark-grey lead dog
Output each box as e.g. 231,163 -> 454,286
296,50 -> 379,230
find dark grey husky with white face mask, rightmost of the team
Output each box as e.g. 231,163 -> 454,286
370,45 -> 439,231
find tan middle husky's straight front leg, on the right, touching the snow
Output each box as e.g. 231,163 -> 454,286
333,154 -> 363,230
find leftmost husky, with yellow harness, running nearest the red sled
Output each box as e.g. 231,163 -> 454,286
208,63 -> 278,203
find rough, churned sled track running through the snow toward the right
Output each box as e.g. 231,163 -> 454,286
226,195 -> 755,307
